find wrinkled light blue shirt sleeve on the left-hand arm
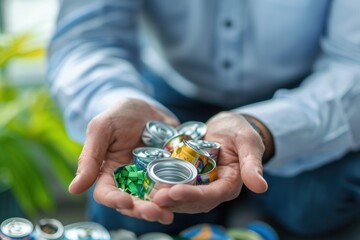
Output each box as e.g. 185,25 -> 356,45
47,0 -> 173,142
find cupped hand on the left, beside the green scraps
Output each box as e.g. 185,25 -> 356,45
69,99 -> 178,224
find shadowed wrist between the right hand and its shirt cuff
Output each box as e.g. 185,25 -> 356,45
243,114 -> 275,164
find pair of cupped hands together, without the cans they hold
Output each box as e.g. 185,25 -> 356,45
69,104 -> 267,224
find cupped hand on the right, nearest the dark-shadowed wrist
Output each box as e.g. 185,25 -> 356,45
153,112 -> 267,213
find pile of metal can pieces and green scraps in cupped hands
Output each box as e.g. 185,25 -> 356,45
114,121 -> 220,200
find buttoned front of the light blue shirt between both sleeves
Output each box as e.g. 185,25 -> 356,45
140,0 -> 330,106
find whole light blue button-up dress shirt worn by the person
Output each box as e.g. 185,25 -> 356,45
48,0 -> 360,176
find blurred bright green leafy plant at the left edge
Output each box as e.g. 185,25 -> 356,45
0,33 -> 81,217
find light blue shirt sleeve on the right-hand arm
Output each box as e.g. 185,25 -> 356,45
235,0 -> 360,176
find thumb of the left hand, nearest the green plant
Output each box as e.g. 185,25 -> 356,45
69,116 -> 111,194
